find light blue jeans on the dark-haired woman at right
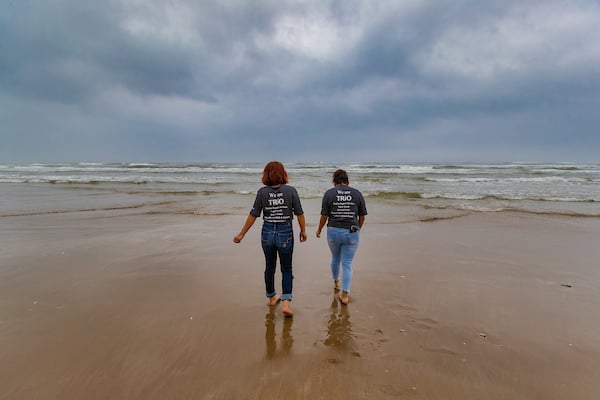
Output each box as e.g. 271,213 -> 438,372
327,226 -> 360,292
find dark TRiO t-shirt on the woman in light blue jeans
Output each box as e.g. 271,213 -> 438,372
321,185 -> 367,228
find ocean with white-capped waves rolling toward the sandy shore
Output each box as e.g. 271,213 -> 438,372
0,163 -> 600,219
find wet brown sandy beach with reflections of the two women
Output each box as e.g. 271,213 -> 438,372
0,208 -> 600,400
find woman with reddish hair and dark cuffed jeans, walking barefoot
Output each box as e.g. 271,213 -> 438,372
233,161 -> 306,317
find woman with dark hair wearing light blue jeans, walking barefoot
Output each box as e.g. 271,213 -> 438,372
317,169 -> 367,304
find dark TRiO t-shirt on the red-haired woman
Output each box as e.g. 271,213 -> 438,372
250,185 -> 304,224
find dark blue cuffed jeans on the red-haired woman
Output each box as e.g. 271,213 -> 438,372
261,223 -> 294,300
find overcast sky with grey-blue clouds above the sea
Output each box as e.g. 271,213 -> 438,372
0,0 -> 600,162
